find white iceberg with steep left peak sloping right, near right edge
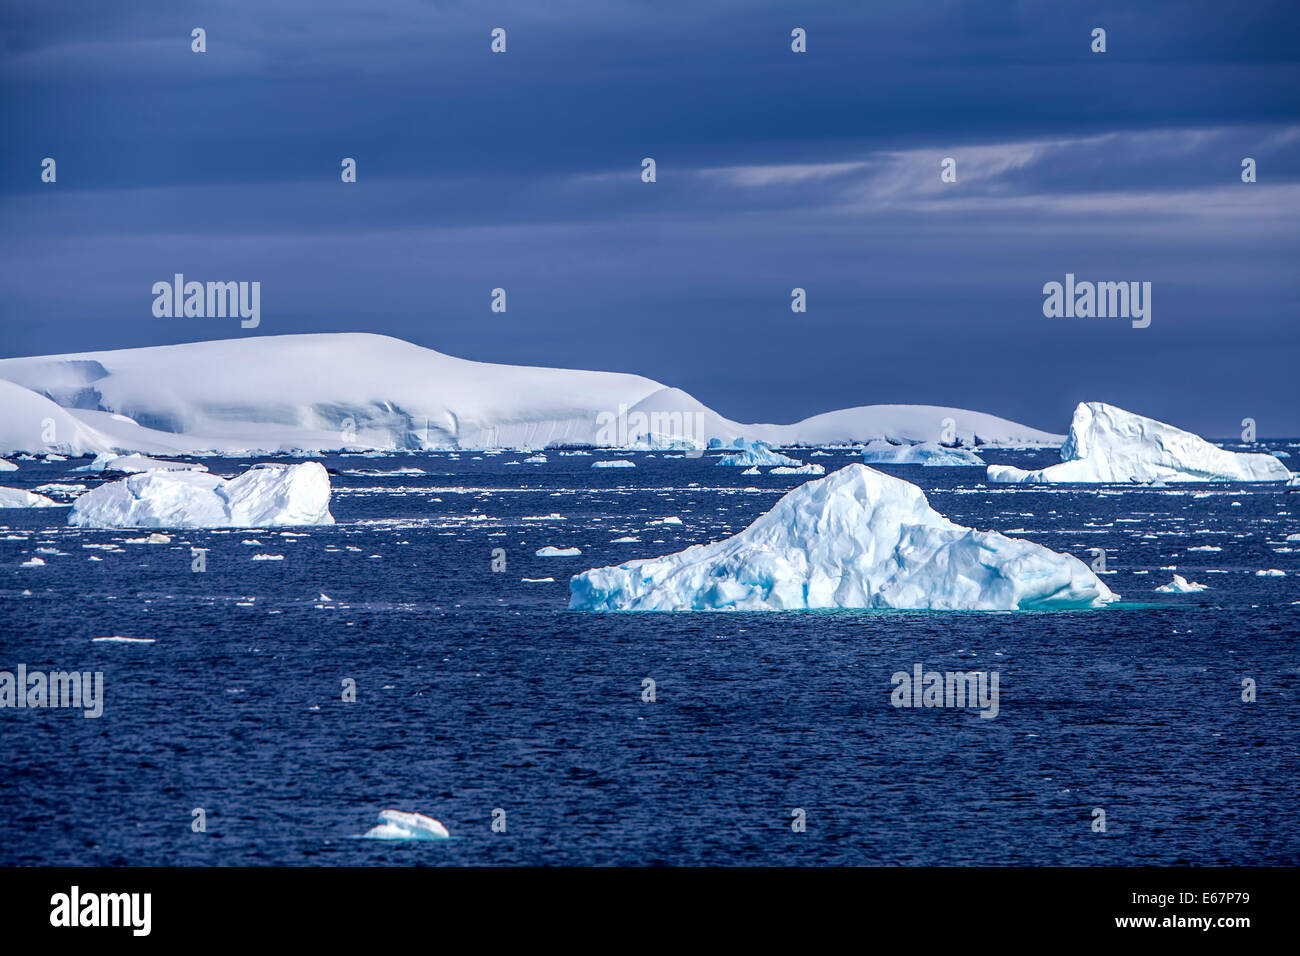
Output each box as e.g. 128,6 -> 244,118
988,402 -> 1291,483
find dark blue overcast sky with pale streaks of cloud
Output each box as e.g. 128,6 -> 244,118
0,0 -> 1300,437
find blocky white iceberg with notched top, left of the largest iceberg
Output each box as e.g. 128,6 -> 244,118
68,462 -> 334,528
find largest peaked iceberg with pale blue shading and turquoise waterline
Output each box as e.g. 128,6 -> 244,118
569,464 -> 1117,611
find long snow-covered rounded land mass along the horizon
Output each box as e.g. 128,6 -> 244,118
0,333 -> 1061,455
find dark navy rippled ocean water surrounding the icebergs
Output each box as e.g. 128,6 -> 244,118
0,449 -> 1300,865
